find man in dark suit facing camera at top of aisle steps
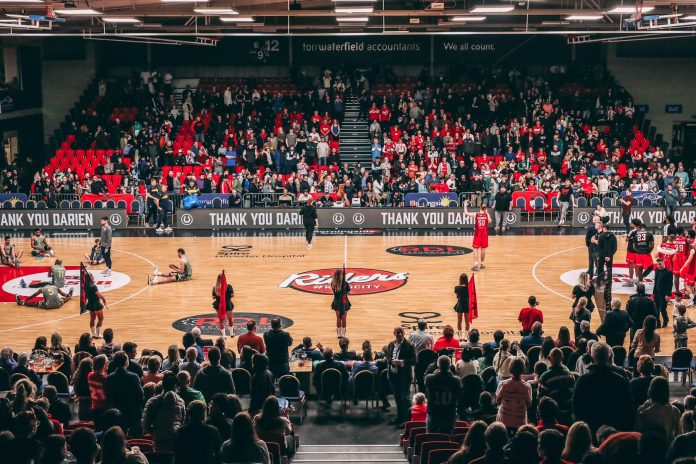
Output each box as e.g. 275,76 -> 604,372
386,327 -> 416,428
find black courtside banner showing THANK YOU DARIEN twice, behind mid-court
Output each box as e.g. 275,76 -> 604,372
178,208 -> 520,230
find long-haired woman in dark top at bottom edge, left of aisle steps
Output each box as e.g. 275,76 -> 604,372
221,412 -> 271,464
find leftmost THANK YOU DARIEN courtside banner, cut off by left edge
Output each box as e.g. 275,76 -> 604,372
0,209 -> 128,230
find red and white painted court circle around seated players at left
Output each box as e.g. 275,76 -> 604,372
0,266 -> 130,302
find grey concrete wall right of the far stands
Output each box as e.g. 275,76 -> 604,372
607,41 -> 696,145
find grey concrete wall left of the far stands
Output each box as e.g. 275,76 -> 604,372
42,42 -> 96,141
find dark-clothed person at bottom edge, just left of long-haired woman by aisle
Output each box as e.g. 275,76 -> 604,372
174,401 -> 222,464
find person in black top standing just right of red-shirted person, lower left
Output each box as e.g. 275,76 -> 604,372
104,351 -> 144,436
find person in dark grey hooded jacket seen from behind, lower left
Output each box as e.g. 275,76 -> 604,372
143,372 -> 186,453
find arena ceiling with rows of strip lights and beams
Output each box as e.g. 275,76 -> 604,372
0,0 -> 696,36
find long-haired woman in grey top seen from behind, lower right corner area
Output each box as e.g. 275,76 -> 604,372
635,377 -> 680,441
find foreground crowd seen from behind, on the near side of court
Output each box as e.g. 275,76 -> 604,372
0,295 -> 696,464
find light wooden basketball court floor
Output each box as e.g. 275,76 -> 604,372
0,236 -> 696,354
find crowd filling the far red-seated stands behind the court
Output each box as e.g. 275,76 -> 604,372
23,66 -> 693,206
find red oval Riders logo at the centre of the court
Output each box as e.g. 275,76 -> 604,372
278,268 -> 408,295
